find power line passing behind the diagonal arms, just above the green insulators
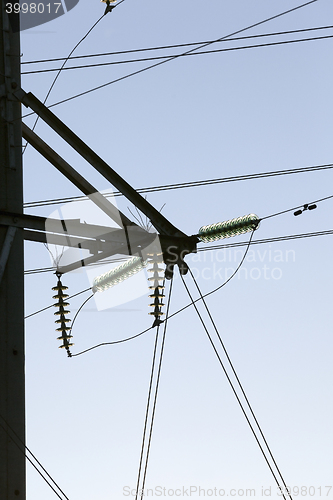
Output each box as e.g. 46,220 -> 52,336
24,163 -> 333,208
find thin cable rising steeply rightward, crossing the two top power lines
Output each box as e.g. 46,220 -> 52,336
22,0 -> 318,114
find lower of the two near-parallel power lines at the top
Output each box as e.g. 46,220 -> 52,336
21,35 -> 333,75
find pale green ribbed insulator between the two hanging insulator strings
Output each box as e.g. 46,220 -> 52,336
92,257 -> 147,293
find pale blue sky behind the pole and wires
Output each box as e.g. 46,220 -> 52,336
21,0 -> 333,500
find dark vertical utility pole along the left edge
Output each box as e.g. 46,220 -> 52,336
0,1 -> 26,500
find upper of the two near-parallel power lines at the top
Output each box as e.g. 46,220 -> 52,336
21,25 -> 333,65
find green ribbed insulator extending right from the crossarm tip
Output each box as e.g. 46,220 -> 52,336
198,214 -> 259,243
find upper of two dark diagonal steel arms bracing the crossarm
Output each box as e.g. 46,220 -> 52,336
14,89 -> 186,237
